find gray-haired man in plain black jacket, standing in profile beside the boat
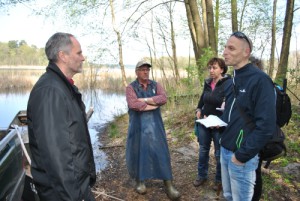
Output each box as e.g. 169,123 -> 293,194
27,33 -> 96,201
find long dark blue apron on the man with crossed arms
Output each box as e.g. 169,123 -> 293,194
126,80 -> 172,181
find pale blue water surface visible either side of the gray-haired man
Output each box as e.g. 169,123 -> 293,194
0,89 -> 127,172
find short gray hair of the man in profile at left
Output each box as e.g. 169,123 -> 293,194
45,32 -> 75,62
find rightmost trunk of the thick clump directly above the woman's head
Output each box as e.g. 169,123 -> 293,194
205,0 -> 218,56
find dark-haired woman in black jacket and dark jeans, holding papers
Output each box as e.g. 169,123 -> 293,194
193,57 -> 230,191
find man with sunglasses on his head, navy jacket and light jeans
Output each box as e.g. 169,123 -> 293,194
220,32 -> 276,201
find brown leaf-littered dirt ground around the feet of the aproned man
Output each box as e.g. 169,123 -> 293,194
94,128 -> 226,201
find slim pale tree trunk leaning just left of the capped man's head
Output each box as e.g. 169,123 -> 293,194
109,0 -> 127,87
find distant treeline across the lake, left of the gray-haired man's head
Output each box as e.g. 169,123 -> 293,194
0,40 -> 48,66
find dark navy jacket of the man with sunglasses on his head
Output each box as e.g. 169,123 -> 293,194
220,64 -> 276,163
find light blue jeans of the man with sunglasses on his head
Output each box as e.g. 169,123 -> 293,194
221,147 -> 258,201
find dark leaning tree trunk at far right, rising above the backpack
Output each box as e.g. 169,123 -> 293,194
275,0 -> 294,81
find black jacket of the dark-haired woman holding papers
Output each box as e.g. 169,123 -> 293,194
197,75 -> 230,117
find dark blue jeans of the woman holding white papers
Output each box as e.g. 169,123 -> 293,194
198,125 -> 221,182
